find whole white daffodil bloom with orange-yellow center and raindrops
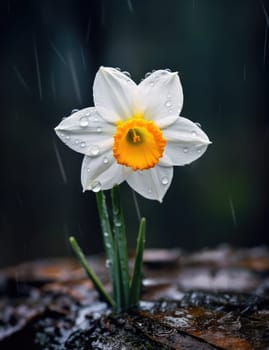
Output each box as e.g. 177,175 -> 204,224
55,67 -> 210,202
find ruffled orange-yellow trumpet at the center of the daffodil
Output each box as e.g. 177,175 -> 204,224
113,117 -> 166,170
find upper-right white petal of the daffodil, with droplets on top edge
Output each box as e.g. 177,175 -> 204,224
138,70 -> 183,127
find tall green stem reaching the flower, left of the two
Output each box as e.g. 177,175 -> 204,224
96,191 -> 120,305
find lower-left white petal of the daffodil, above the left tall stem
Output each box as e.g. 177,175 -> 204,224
81,151 -> 131,192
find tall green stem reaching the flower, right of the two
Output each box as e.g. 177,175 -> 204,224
111,185 -> 129,310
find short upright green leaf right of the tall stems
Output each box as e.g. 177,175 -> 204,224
130,218 -> 146,306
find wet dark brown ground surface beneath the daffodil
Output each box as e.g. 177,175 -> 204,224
0,246 -> 269,350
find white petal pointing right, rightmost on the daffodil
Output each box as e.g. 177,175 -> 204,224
162,117 -> 211,165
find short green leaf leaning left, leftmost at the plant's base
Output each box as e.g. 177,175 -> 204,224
69,236 -> 115,308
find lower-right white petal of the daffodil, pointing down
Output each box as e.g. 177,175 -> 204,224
126,163 -> 173,202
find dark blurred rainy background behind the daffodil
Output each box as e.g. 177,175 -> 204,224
0,0 -> 269,266
